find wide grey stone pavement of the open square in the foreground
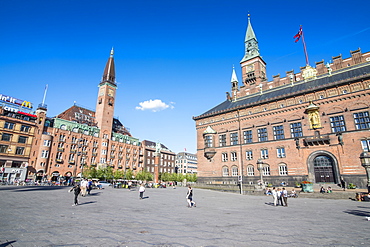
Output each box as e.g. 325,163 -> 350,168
0,186 -> 370,247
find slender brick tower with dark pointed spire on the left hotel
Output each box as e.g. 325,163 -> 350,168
95,48 -> 117,139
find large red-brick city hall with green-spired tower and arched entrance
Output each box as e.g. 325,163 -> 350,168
193,16 -> 370,187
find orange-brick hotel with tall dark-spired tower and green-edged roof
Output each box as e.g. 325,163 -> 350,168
28,49 -> 142,181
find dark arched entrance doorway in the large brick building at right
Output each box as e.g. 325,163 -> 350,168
313,155 -> 335,183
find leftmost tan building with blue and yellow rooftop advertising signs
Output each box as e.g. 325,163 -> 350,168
0,94 -> 37,183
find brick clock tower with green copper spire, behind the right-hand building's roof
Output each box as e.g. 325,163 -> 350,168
240,14 -> 266,86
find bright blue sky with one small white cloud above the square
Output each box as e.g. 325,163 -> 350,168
0,0 -> 370,153
